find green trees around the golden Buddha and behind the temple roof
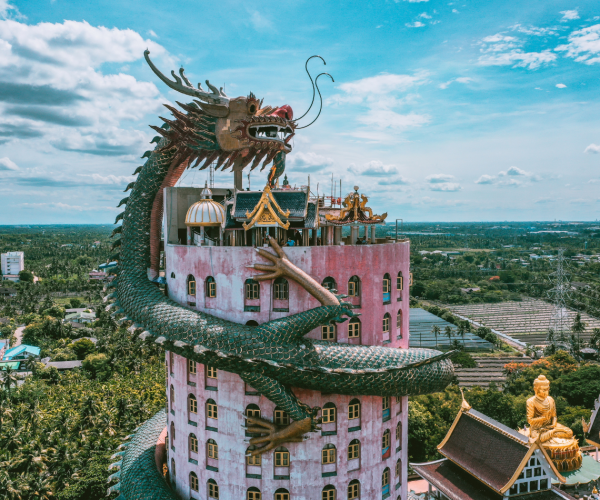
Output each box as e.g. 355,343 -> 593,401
408,351 -> 600,462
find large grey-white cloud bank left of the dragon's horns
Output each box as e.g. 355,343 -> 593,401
0,20 -> 166,155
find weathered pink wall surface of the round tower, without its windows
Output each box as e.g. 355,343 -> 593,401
166,242 -> 409,500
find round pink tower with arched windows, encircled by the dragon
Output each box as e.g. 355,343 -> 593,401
164,184 -> 410,500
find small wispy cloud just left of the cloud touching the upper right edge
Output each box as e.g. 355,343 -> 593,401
478,33 -> 556,69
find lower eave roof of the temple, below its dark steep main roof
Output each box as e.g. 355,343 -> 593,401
411,458 -> 570,500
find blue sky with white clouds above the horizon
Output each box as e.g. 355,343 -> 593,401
0,0 -> 600,224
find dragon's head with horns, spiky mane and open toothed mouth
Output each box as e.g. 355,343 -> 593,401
144,50 -> 296,183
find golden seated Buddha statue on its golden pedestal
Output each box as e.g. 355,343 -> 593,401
519,375 -> 583,472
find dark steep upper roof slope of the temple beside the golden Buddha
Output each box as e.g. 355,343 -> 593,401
439,412 -> 529,492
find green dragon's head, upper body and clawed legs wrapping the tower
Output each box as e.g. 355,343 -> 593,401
107,51 -> 453,470
